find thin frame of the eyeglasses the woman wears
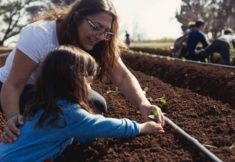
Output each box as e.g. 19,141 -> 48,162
85,17 -> 114,41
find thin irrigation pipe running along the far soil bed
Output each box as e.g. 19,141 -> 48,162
127,51 -> 235,69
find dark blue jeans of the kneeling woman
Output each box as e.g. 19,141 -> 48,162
0,82 -> 107,113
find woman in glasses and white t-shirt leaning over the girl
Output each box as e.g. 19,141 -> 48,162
0,0 -> 164,142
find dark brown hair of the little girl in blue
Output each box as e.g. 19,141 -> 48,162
24,46 -> 97,126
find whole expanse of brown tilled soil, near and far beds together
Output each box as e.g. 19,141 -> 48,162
0,47 -> 235,162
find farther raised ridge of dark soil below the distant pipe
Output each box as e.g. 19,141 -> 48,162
122,52 -> 235,109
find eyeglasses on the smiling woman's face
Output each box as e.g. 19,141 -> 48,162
86,18 -> 114,40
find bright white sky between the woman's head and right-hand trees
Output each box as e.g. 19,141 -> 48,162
113,0 -> 182,40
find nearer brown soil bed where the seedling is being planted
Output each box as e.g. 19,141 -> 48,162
61,68 -> 235,162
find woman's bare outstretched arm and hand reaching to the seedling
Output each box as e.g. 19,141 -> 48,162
110,58 -> 164,125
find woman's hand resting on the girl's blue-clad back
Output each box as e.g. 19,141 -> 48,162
1,115 -> 24,143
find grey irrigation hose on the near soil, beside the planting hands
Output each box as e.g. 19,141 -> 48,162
165,116 -> 222,162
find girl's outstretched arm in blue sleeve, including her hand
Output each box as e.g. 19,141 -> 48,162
66,109 -> 164,143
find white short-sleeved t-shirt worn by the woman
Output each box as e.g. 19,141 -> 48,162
0,20 -> 59,84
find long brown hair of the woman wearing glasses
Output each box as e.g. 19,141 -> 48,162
34,0 -> 120,78
